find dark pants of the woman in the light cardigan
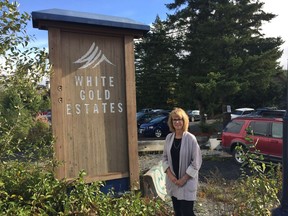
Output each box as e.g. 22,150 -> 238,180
172,196 -> 195,216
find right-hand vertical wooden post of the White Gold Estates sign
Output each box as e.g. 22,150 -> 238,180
124,36 -> 140,190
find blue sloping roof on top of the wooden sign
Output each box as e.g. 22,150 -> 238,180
32,9 -> 150,32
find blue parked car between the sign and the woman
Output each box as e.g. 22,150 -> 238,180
138,116 -> 170,138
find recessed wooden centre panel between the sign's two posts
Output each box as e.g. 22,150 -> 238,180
56,31 -> 129,178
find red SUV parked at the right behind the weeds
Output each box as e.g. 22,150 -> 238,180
221,117 -> 283,164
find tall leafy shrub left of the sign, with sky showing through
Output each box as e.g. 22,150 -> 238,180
0,0 -> 52,160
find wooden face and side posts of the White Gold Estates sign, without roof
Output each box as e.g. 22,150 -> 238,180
48,24 -> 140,187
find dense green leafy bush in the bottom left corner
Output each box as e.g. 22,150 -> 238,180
0,161 -> 66,215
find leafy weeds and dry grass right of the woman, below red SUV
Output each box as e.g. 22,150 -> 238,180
196,149 -> 282,216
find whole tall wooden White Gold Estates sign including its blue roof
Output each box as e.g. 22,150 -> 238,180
32,9 -> 149,190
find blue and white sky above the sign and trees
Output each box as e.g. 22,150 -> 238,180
17,0 -> 288,69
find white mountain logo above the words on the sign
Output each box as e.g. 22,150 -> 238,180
74,42 -> 115,69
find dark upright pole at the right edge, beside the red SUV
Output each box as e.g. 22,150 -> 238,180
272,59 -> 288,216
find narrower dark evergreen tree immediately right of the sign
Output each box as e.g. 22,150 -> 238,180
135,16 -> 178,109
